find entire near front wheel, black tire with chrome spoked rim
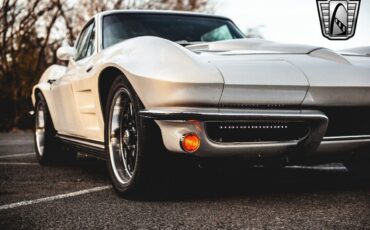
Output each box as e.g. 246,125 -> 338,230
105,76 -> 168,199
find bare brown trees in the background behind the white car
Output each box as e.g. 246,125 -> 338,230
0,0 -> 208,131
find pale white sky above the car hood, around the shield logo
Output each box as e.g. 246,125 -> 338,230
214,0 -> 370,50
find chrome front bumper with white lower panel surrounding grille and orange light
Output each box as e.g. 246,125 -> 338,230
140,108 -> 370,158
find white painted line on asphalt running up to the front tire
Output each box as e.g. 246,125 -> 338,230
0,185 -> 112,210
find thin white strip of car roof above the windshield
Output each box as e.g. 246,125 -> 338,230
96,10 -> 230,20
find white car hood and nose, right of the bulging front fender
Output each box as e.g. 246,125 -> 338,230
187,39 -> 370,106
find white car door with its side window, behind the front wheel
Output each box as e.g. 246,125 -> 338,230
51,20 -> 96,137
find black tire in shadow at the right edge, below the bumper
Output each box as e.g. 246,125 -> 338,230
344,153 -> 370,184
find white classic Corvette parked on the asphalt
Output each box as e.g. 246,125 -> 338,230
32,10 -> 370,195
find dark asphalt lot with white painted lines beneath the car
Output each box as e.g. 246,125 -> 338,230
0,133 -> 370,229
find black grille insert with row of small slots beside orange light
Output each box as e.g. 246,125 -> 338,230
205,121 -> 309,143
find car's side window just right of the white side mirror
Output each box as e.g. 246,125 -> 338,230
76,23 -> 95,61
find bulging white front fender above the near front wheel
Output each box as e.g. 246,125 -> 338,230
98,36 -> 224,107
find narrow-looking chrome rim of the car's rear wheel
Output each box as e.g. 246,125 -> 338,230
35,103 -> 45,156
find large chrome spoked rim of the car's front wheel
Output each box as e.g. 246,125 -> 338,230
108,89 -> 138,184
